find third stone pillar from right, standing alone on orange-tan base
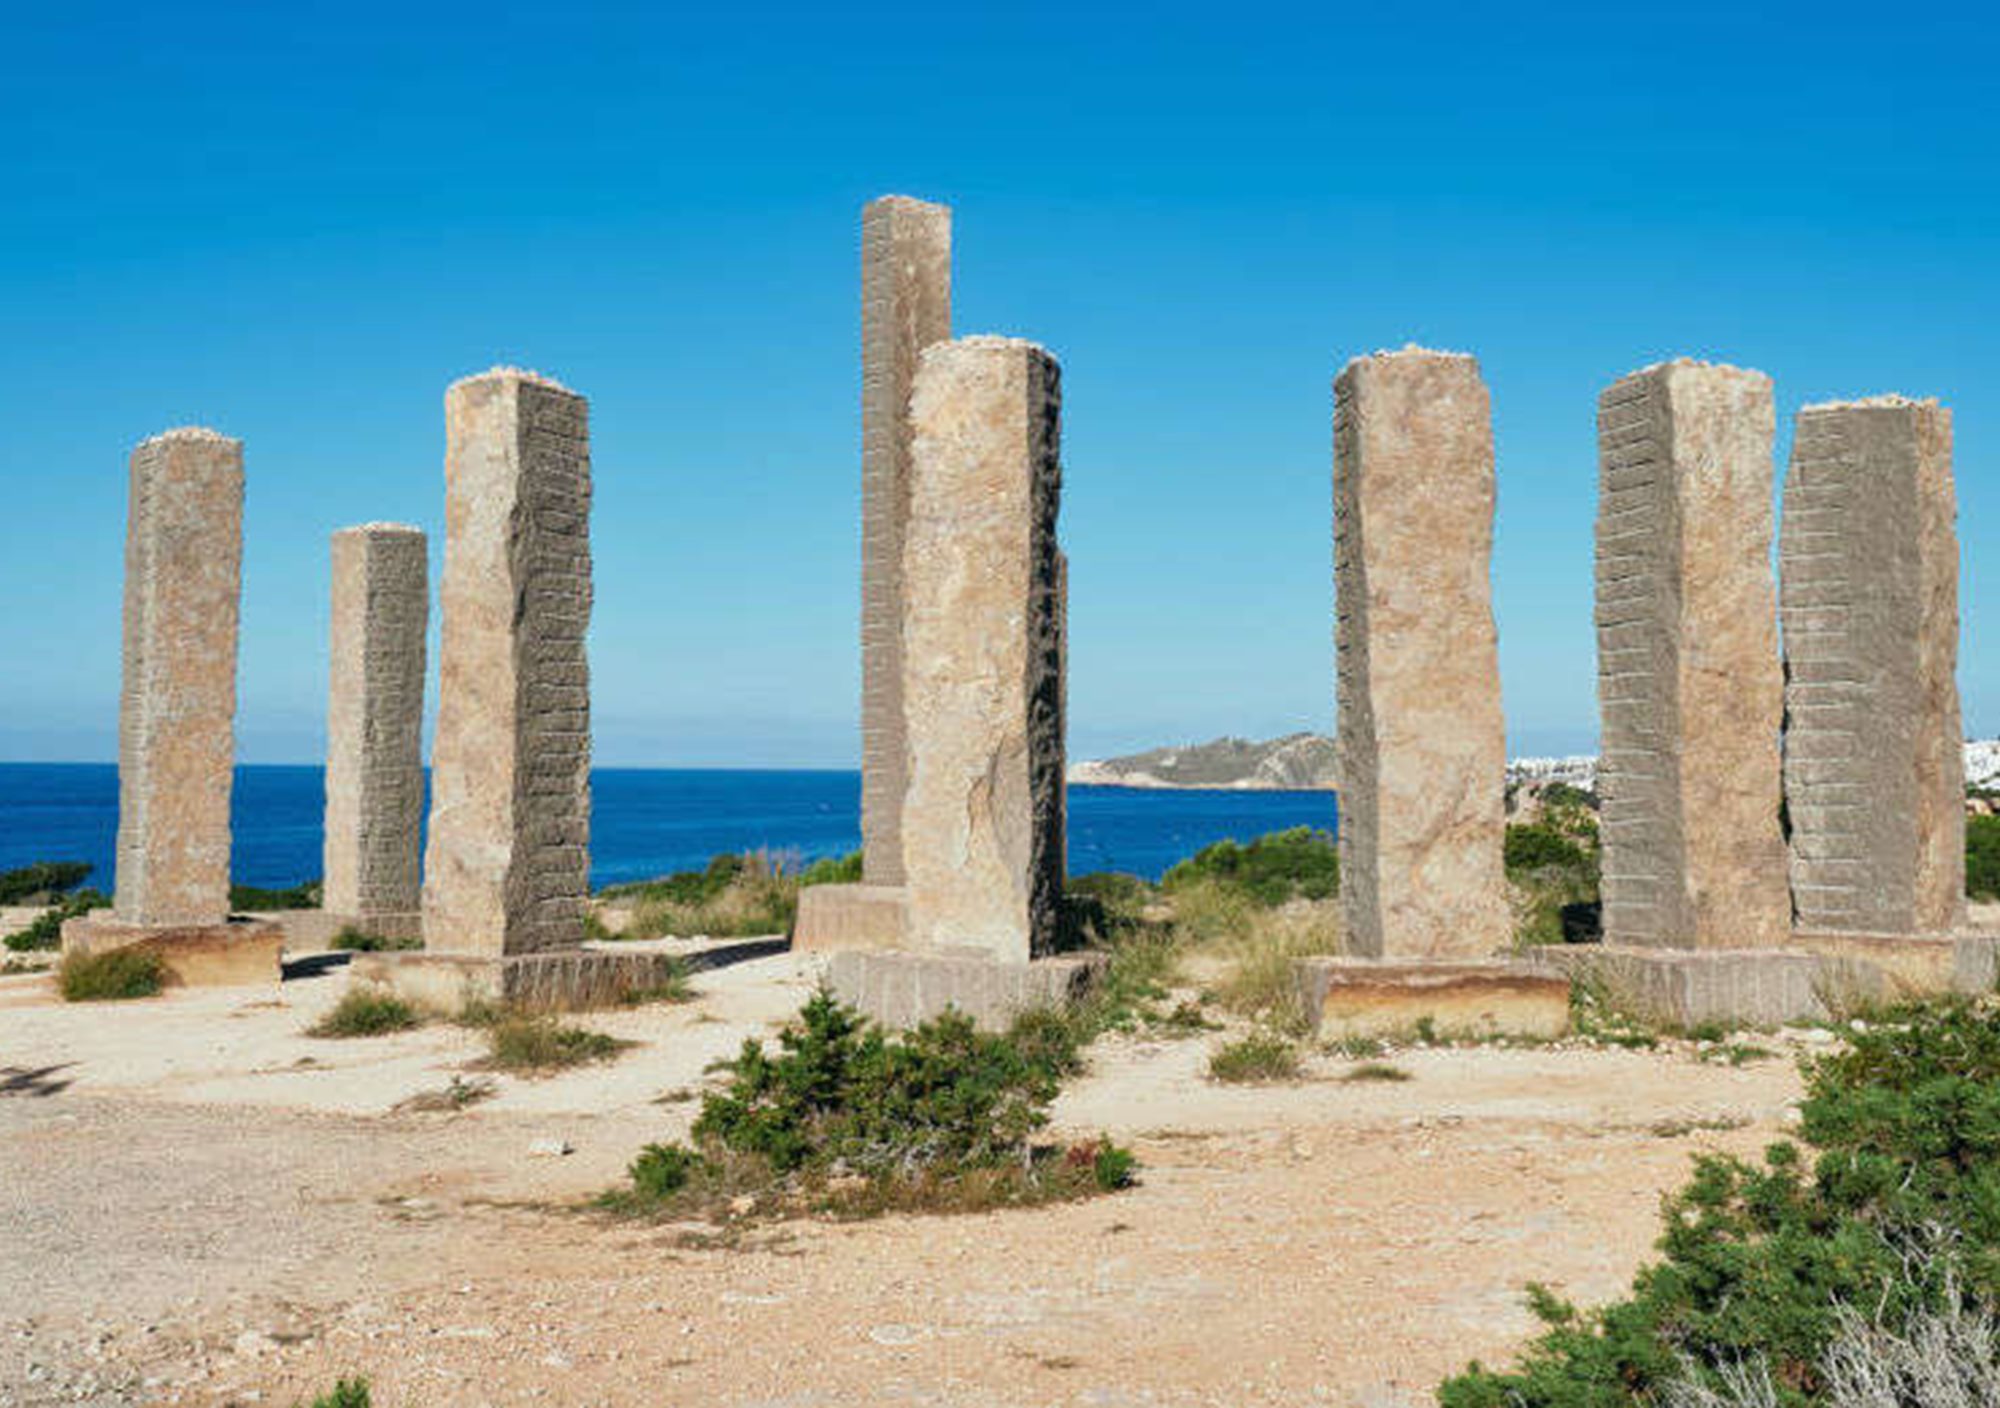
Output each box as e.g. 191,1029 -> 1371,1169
1334,348 -> 1512,960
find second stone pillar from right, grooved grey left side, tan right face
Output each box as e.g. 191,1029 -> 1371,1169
1596,360 -> 1790,948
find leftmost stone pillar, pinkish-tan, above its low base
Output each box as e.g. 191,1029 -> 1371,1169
116,430 -> 244,926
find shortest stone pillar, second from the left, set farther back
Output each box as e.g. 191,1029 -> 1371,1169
322,524 -> 430,938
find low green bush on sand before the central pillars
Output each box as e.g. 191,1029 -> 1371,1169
604,992 -> 1132,1214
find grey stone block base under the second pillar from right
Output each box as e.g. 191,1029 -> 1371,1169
1530,944 -> 1888,1028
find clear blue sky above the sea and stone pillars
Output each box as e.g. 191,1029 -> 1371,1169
0,0 -> 2000,766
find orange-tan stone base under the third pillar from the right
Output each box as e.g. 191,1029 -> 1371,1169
1298,958 -> 1570,1040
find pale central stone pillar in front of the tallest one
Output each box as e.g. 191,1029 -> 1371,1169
902,338 -> 1064,962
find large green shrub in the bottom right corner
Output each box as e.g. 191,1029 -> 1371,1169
1438,1004 -> 2000,1408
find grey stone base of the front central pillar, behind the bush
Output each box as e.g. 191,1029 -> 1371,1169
826,948 -> 1104,1032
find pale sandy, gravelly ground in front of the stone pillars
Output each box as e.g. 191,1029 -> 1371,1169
0,954 -> 1798,1408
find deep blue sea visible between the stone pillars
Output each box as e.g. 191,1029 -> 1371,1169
0,762 -> 1334,892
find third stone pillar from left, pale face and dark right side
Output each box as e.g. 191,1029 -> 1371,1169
424,368 -> 590,956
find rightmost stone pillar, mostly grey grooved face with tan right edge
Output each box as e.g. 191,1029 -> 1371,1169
1778,396 -> 1966,934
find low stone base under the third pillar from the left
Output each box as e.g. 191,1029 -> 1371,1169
348,948 -> 680,1012
